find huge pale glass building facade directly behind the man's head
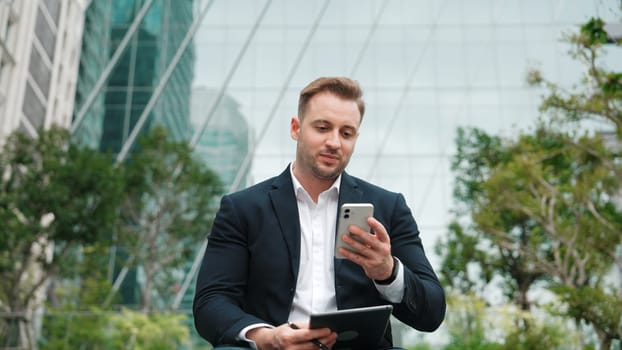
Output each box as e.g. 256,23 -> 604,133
195,0 -> 620,270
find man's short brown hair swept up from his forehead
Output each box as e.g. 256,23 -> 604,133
298,77 -> 365,121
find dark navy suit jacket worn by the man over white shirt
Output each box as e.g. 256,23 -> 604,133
193,168 -> 445,347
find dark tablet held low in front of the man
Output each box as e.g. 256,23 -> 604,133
309,305 -> 393,350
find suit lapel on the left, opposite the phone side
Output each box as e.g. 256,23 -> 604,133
270,167 -> 300,280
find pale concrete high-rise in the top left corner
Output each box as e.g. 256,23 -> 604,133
0,0 -> 86,144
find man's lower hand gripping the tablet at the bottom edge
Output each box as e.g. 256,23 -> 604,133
246,323 -> 337,350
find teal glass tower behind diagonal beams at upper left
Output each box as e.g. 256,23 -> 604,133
74,0 -> 194,153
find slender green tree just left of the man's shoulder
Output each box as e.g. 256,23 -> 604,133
109,127 -> 223,311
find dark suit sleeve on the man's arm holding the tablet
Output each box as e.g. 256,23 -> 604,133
193,196 -> 264,345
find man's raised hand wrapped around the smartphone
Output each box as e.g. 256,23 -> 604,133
339,217 -> 394,281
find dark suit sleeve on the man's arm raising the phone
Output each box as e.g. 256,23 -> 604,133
387,194 -> 446,332
